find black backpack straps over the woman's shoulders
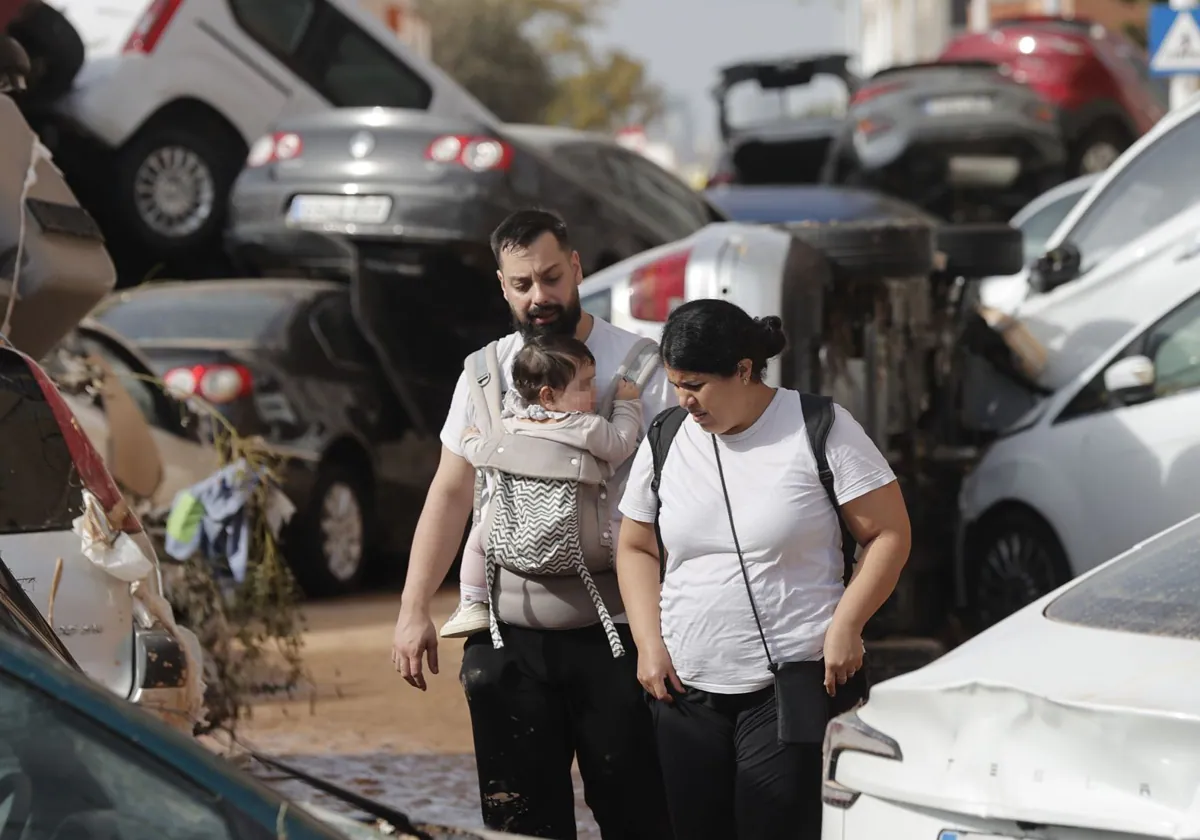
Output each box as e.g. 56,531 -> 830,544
646,394 -> 858,586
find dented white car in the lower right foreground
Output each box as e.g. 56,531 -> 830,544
822,511 -> 1200,840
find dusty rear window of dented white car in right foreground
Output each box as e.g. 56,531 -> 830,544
1045,517 -> 1200,640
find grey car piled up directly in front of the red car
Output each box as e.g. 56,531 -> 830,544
822,61 -> 1067,222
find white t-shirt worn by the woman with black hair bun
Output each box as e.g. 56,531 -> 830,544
620,389 -> 895,694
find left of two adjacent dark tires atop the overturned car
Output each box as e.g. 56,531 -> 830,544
787,221 -> 934,280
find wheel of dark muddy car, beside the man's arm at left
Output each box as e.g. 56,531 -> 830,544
284,462 -> 376,598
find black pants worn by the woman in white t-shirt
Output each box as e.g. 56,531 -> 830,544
649,688 -> 821,840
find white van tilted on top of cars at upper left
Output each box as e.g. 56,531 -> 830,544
55,0 -> 494,258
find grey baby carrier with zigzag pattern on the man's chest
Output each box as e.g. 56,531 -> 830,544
466,338 -> 658,656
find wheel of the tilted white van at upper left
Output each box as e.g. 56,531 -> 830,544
116,116 -> 245,259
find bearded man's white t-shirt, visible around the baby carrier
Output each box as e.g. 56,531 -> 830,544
442,318 -> 678,534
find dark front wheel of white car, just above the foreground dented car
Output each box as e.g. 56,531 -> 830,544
965,508 -> 1072,630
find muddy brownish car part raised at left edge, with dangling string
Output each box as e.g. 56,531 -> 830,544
0,96 -> 116,359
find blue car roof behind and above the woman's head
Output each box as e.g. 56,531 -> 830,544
704,185 -> 938,224
